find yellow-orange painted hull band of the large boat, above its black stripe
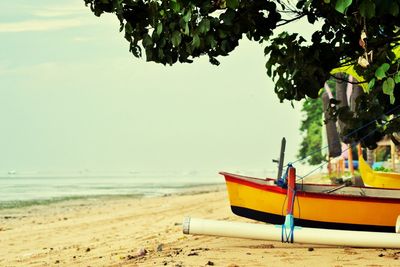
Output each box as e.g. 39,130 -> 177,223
226,180 -> 400,226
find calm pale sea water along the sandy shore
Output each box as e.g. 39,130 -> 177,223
0,172 -> 224,209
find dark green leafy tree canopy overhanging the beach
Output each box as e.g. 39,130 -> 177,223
84,0 -> 400,148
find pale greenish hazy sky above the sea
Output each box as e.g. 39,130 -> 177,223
0,0 -> 318,178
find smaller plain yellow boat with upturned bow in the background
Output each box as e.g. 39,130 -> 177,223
359,156 -> 400,189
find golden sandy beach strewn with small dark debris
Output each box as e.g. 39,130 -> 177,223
0,186 -> 400,267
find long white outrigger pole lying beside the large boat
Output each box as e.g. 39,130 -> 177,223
183,217 -> 400,248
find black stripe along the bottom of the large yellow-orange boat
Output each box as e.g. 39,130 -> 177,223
231,206 -> 395,233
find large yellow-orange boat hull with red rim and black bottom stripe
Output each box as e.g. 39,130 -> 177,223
220,172 -> 400,233
